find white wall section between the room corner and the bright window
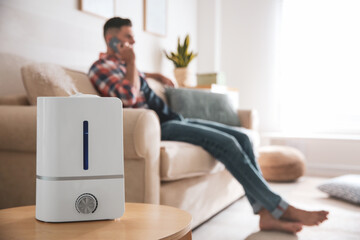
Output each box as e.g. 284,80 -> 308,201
221,0 -> 282,131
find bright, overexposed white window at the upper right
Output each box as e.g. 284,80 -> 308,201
279,0 -> 360,134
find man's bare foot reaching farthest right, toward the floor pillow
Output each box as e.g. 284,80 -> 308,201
281,206 -> 329,226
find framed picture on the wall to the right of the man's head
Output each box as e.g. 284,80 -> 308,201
144,0 -> 167,37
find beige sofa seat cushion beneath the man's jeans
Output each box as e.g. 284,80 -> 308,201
160,141 -> 224,181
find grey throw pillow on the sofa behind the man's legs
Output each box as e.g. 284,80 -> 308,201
165,88 -> 240,126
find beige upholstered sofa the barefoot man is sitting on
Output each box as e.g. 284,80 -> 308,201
0,53 -> 257,228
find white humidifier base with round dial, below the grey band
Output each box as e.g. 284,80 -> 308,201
36,176 -> 125,222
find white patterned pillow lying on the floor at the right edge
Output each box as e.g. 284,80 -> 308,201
318,175 -> 360,204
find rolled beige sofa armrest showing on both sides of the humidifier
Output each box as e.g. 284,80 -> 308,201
0,105 -> 160,154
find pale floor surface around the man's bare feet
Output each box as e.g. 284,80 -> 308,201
193,177 -> 360,240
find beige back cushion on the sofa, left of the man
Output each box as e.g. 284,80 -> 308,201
21,63 -> 97,105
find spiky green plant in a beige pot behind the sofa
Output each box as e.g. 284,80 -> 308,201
164,34 -> 197,87
